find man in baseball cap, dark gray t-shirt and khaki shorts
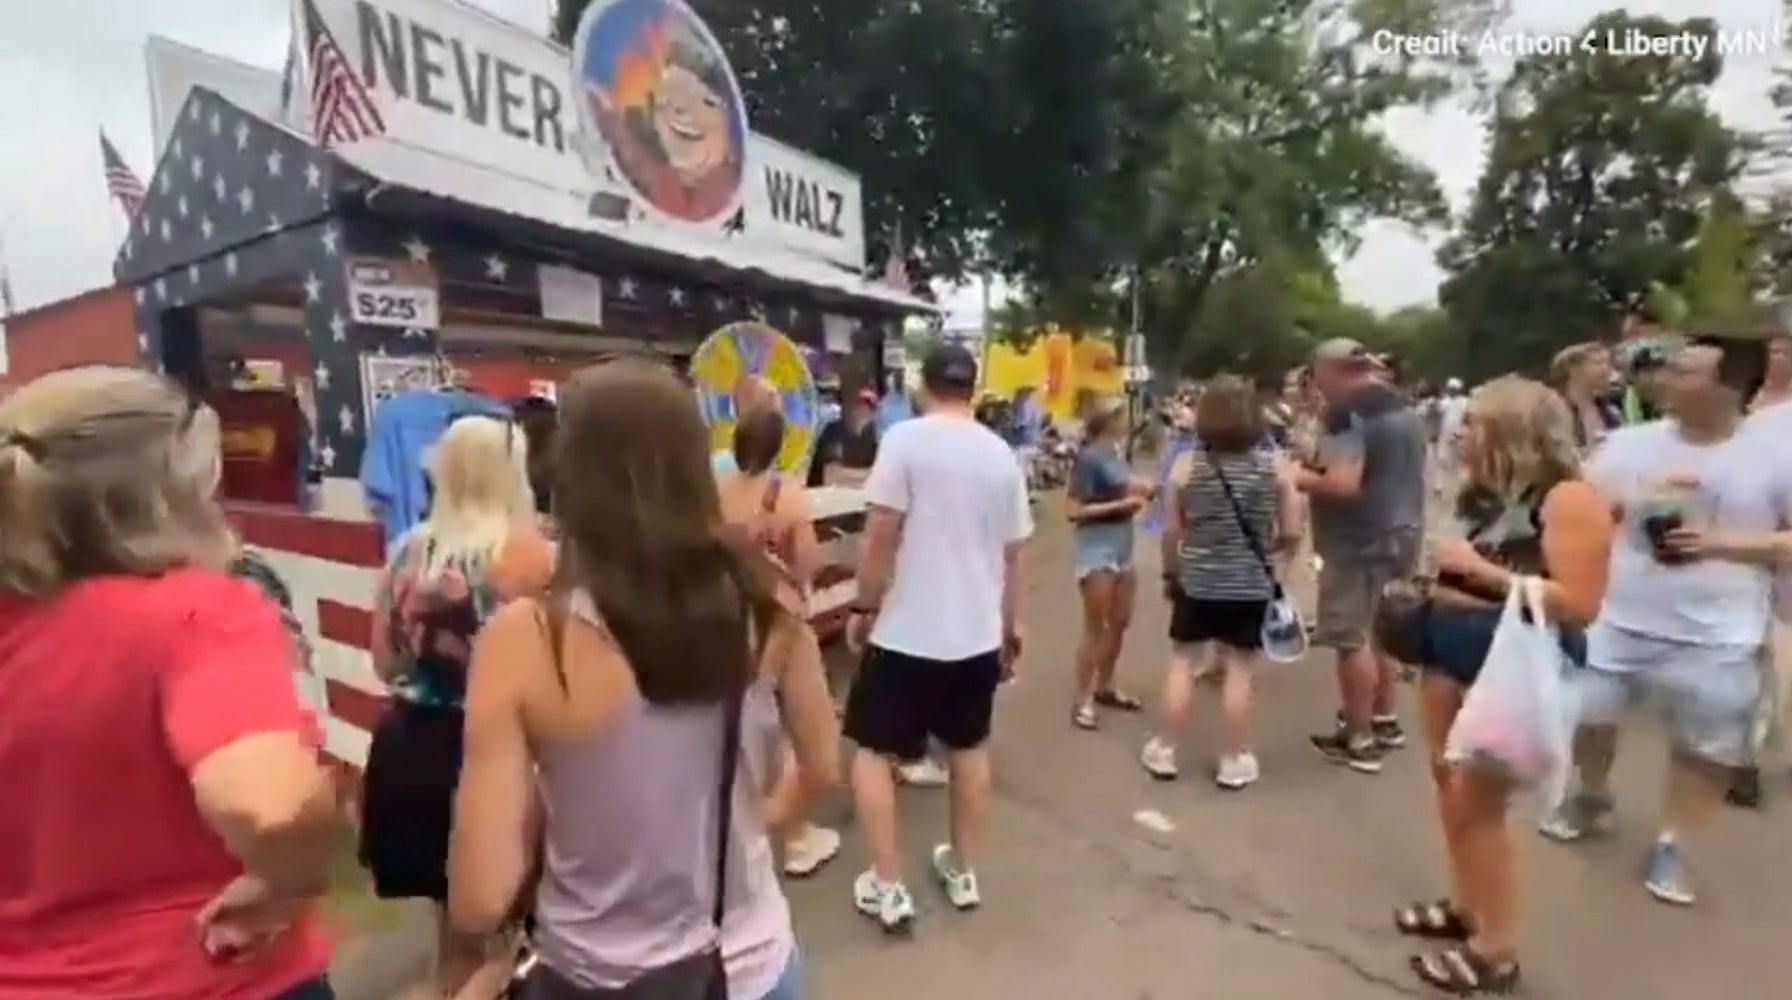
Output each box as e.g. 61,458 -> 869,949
1296,337 -> 1426,774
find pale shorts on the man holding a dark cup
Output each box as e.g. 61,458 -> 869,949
1572,627 -> 1762,767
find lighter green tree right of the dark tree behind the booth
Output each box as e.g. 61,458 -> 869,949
1140,0 -> 1503,371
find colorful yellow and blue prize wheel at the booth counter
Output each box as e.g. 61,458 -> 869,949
690,323 -> 821,473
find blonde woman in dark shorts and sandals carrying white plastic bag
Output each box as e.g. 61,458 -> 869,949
1394,376 -> 1615,996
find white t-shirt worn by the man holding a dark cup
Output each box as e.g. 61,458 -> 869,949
1586,419 -> 1792,659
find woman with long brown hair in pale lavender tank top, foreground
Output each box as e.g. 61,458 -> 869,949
448,358 -> 839,1000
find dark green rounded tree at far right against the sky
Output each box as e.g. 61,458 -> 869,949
1439,11 -> 1751,376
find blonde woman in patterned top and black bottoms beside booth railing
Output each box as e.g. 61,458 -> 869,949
360,416 -> 554,1000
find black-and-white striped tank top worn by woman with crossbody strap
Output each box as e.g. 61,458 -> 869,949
1177,450 -> 1276,600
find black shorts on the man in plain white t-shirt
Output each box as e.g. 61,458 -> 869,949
846,647 -> 1002,760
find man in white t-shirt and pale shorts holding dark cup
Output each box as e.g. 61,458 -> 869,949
1543,341 -> 1792,905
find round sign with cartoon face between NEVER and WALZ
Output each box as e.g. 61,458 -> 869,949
572,0 -> 747,222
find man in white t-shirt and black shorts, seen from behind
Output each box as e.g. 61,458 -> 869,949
846,344 -> 1032,932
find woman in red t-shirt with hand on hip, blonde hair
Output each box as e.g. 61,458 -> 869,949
0,366 -> 339,1000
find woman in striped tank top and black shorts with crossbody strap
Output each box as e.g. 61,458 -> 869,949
1140,376 -> 1301,790
